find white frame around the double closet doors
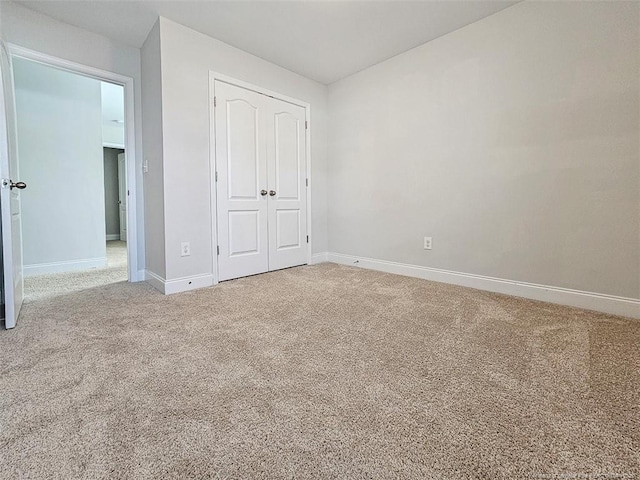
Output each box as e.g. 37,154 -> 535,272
209,70 -> 313,285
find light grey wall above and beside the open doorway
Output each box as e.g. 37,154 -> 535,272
0,2 -> 145,269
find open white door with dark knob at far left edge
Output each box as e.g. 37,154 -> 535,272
0,41 -> 26,328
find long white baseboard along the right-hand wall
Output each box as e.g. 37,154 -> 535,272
318,252 -> 640,319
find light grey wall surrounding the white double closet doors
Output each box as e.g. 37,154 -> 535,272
148,18 -> 327,279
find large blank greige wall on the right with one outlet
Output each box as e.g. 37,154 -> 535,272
328,2 -> 640,298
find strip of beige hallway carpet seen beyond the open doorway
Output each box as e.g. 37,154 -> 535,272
24,240 -> 128,303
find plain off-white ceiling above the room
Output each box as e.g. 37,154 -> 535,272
17,0 -> 516,84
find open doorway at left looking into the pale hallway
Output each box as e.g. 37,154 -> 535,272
13,58 -> 128,301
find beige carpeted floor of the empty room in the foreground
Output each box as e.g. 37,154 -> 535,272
0,264 -> 640,480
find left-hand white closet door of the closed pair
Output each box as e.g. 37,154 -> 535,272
215,82 -> 269,281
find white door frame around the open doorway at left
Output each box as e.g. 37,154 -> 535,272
7,43 -> 144,282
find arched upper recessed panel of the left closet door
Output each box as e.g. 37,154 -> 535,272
225,99 -> 260,200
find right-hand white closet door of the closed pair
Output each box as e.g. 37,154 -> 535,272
267,99 -> 307,270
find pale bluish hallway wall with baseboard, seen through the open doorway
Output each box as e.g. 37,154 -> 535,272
13,58 -> 106,275
